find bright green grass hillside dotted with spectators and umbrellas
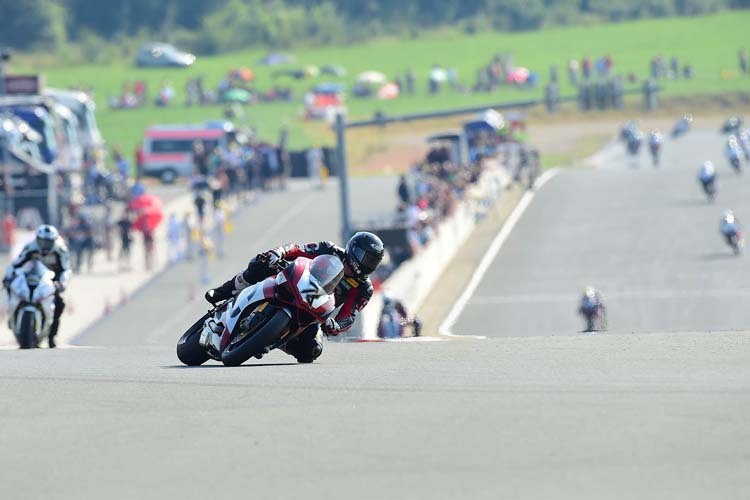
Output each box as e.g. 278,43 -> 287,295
11,11 -> 750,164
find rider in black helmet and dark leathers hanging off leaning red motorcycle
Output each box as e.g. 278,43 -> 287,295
206,232 -> 385,363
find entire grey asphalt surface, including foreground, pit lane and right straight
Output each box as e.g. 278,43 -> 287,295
0,132 -> 750,499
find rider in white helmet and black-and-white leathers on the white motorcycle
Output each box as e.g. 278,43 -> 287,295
3,224 -> 71,348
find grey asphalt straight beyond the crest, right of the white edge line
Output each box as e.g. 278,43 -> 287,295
452,130 -> 750,337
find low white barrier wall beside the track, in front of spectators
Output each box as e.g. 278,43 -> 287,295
341,163 -> 511,340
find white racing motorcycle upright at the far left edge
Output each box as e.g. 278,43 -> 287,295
8,259 -> 56,349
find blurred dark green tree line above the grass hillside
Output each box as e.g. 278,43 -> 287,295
0,0 -> 750,54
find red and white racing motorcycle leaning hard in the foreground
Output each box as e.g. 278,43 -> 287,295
177,255 -> 344,366
